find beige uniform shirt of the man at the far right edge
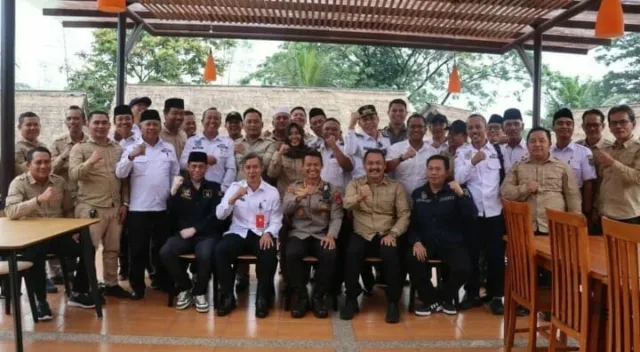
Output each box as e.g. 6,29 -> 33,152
598,136 -> 640,220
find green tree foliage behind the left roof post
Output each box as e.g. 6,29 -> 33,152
67,29 -> 236,111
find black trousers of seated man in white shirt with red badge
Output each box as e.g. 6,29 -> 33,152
215,231 -> 278,299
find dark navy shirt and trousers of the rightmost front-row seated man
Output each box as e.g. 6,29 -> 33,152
408,183 -> 478,305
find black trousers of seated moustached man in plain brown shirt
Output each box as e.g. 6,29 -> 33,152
344,233 -> 404,302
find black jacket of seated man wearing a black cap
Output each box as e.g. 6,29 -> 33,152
168,180 -> 225,236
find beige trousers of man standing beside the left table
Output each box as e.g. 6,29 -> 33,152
75,204 -> 122,286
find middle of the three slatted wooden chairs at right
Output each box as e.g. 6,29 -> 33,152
547,209 -> 591,352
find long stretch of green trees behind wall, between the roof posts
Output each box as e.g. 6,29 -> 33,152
243,43 -> 529,109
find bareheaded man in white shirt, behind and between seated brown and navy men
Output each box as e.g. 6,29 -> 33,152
387,114 -> 438,195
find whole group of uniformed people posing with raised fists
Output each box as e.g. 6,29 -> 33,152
5,97 -> 640,323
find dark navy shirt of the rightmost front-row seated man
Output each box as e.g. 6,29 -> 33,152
409,183 -> 478,246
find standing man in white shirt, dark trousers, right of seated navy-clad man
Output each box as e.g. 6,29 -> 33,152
454,114 -> 505,315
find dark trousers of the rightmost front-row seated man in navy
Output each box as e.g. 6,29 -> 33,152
407,243 -> 471,304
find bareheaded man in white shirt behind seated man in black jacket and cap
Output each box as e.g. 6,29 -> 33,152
180,108 -> 236,191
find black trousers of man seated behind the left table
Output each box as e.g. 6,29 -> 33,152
22,236 -> 89,301
